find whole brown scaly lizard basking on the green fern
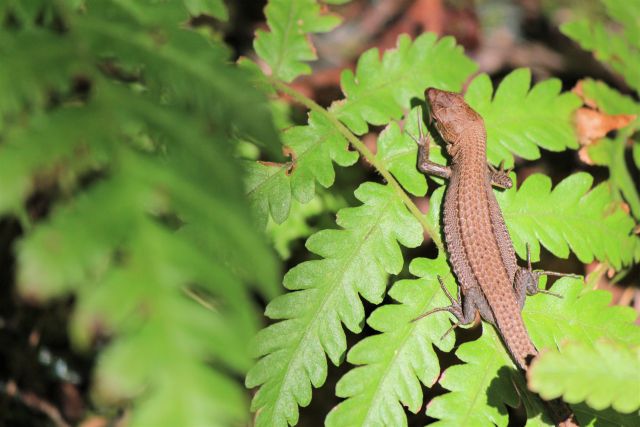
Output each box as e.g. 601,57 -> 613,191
418,88 -> 577,426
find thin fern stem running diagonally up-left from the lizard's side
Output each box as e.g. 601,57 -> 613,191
269,77 -> 444,250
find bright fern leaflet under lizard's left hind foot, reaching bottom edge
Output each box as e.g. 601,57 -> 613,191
326,257 -> 455,426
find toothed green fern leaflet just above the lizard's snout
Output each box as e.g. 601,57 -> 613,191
330,34 -> 476,135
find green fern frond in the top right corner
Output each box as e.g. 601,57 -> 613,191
560,0 -> 640,93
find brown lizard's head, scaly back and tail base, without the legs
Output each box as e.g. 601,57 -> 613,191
429,91 -> 537,369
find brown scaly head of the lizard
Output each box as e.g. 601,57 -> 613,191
426,88 -> 484,157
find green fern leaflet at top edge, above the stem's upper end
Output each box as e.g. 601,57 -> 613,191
253,0 -> 341,82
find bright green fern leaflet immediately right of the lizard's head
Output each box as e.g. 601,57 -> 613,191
465,68 -> 581,165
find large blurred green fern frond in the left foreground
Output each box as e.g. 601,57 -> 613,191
0,1 -> 278,426
